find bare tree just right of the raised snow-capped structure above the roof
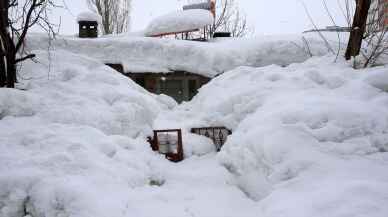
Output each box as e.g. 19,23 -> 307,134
211,0 -> 253,37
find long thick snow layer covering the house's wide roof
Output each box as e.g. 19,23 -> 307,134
28,35 -> 337,77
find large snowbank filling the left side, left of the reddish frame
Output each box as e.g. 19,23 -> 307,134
0,48 -> 171,217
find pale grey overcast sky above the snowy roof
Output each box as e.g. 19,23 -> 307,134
53,0 -> 344,35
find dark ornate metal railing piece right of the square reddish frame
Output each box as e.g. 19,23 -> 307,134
191,127 -> 232,151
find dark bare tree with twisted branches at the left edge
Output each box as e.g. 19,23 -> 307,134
0,0 -> 55,88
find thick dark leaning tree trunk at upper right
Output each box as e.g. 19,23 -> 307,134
345,0 -> 371,60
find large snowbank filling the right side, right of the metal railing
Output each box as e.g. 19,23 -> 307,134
171,56 -> 388,217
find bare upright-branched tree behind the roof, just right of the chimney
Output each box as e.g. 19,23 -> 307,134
88,0 -> 132,34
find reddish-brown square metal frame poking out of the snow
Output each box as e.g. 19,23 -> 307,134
148,129 -> 184,162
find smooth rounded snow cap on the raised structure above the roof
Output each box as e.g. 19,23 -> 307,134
145,9 -> 214,36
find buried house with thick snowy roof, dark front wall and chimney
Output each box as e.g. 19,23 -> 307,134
27,9 -> 328,102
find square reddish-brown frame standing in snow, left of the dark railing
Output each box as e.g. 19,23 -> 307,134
148,129 -> 184,162
